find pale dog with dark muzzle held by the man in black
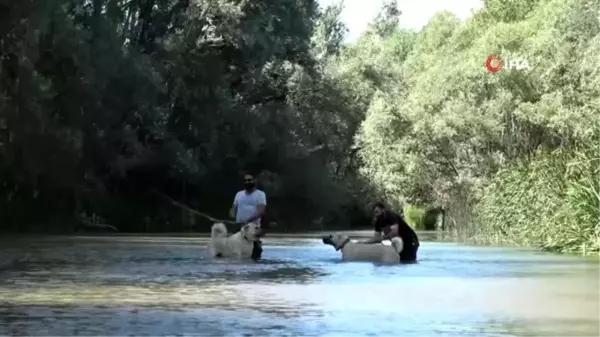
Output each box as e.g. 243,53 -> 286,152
323,233 -> 404,263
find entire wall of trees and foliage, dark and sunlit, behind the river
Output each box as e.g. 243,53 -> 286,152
0,0 -> 600,252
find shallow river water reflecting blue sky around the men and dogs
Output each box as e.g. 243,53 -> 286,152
0,233 -> 600,337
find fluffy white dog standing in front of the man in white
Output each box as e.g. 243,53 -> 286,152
207,222 -> 262,258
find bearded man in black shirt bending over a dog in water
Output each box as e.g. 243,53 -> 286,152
361,202 -> 419,263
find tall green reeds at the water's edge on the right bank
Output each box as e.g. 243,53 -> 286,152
469,142 -> 600,255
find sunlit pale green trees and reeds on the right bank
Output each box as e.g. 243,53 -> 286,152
346,0 -> 600,252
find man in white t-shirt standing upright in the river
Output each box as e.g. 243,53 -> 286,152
229,174 -> 267,259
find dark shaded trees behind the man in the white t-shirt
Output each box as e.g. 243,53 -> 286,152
0,0 -> 367,231
